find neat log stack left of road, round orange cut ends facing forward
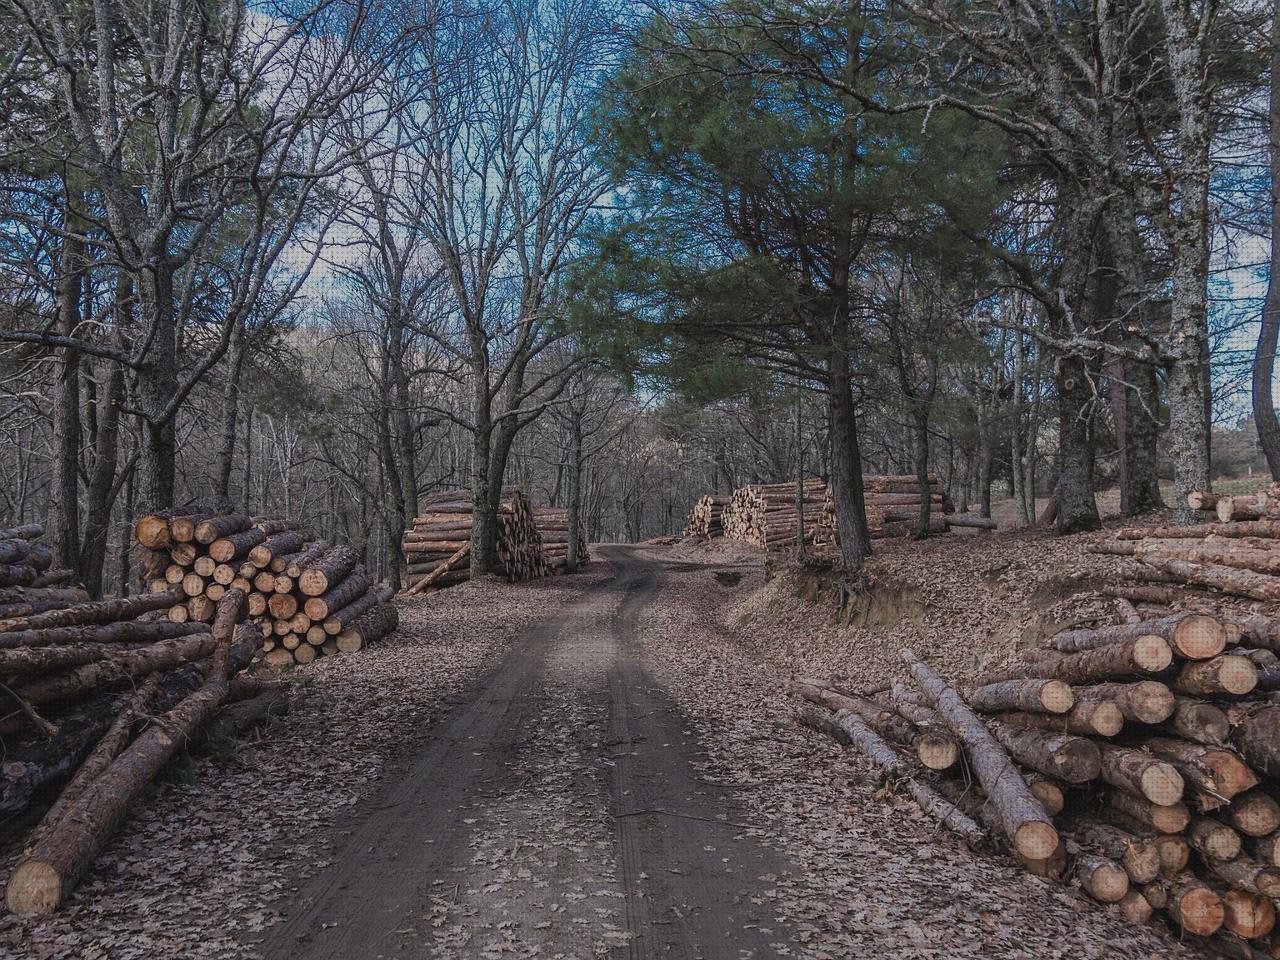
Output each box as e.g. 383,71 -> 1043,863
134,506 -> 399,667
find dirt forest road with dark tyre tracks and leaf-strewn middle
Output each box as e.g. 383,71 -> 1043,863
261,547 -> 795,960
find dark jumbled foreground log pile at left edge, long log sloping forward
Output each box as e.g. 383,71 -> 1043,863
0,542 -> 284,914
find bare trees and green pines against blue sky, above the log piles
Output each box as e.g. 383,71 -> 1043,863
0,0 -> 1280,594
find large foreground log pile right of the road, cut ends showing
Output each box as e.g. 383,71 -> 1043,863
791,604 -> 1280,957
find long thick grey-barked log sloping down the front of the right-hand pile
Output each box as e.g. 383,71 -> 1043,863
901,650 -> 1059,860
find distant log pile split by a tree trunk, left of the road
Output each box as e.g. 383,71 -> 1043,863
402,489 -> 553,593
